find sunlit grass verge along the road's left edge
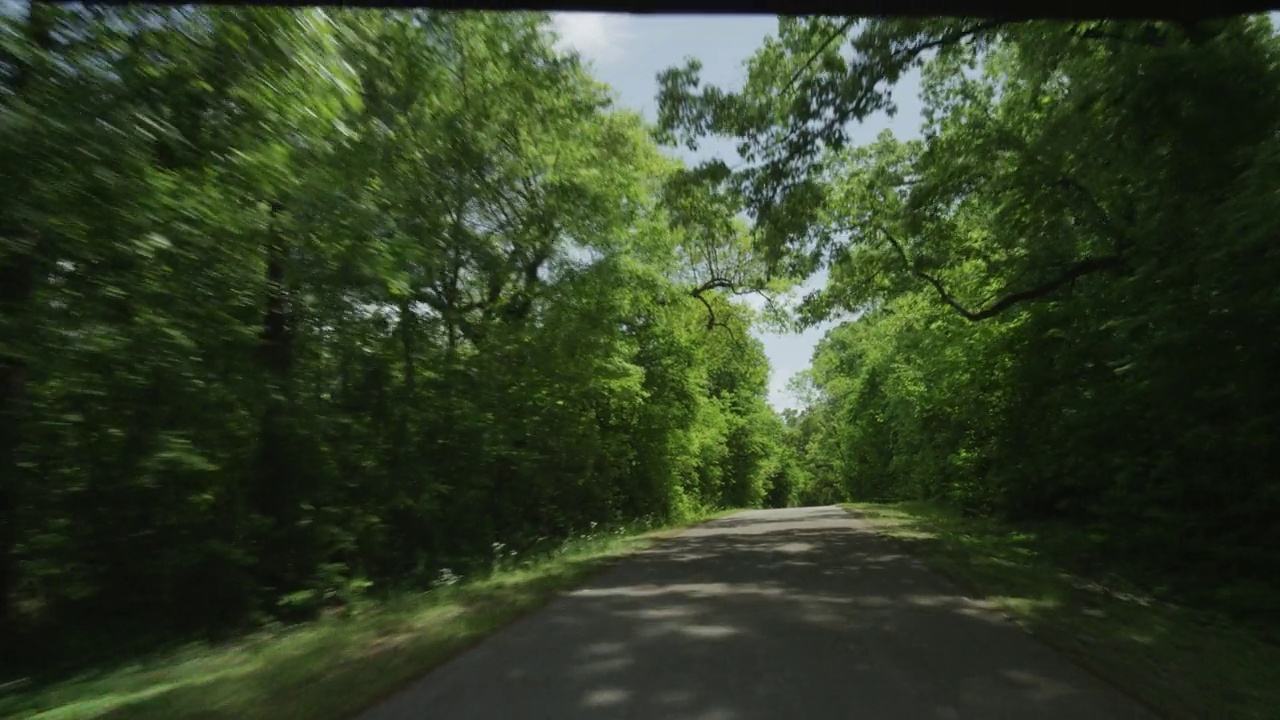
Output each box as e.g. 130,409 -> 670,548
0,510 -> 735,720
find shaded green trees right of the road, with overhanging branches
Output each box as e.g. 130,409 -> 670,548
662,17 -> 1280,614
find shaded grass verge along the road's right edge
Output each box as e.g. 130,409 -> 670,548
841,502 -> 1280,720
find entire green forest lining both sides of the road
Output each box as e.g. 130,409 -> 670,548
0,4 -> 1280,674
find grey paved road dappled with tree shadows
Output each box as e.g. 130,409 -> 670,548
360,507 -> 1156,720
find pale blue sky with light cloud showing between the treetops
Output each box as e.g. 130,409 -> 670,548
553,13 -> 920,410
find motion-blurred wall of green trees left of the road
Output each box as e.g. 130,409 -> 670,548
0,4 -> 796,673
